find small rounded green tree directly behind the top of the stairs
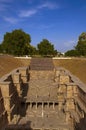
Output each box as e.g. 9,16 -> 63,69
37,39 -> 57,56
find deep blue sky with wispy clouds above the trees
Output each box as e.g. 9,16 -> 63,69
0,0 -> 86,52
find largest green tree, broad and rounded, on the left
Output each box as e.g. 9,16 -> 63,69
2,29 -> 31,55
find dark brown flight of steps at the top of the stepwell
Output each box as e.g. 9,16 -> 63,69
30,58 -> 54,70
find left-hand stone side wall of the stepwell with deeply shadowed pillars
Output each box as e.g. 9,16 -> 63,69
0,67 -> 29,130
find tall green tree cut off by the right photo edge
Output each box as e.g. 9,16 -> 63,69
75,32 -> 86,56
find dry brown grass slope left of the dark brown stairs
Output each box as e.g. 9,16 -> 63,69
0,56 -> 30,77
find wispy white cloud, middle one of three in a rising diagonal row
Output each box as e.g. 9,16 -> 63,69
19,9 -> 37,17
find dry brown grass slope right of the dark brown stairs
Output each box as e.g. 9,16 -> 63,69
54,59 -> 86,84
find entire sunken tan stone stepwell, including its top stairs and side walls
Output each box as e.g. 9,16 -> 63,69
0,58 -> 86,130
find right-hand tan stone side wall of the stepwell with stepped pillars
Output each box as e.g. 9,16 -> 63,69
55,68 -> 86,130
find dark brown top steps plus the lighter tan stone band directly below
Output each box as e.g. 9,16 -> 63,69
30,58 -> 54,80
